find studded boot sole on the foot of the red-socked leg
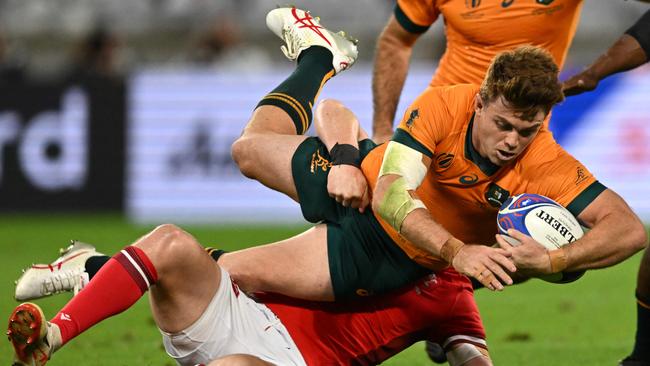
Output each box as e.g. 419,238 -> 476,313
7,303 -> 62,366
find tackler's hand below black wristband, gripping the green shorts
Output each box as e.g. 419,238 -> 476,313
327,164 -> 370,213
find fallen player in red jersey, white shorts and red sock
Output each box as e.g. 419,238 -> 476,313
7,224 -> 491,366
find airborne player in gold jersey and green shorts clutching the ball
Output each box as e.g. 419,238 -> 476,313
219,7 -> 646,308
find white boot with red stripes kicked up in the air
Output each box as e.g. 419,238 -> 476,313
266,7 -> 359,74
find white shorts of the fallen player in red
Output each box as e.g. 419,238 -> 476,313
160,269 -> 305,365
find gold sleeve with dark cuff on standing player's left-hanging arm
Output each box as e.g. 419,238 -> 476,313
395,0 -> 439,33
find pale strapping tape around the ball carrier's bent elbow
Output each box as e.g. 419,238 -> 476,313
373,141 -> 431,232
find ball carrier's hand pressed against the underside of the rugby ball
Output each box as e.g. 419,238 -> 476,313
496,229 -> 552,276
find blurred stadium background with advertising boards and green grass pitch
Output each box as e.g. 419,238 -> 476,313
0,0 -> 650,365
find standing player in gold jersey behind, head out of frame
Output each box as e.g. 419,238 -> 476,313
373,0 -> 582,142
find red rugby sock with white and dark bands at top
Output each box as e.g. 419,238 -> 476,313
50,246 -> 158,344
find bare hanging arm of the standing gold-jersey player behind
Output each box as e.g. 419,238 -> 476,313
372,31 -> 412,136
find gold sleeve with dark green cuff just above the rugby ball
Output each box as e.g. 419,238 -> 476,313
529,137 -> 607,217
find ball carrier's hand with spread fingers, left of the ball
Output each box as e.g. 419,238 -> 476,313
451,244 -> 517,291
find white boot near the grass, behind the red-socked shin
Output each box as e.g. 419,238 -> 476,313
15,241 -> 104,301
